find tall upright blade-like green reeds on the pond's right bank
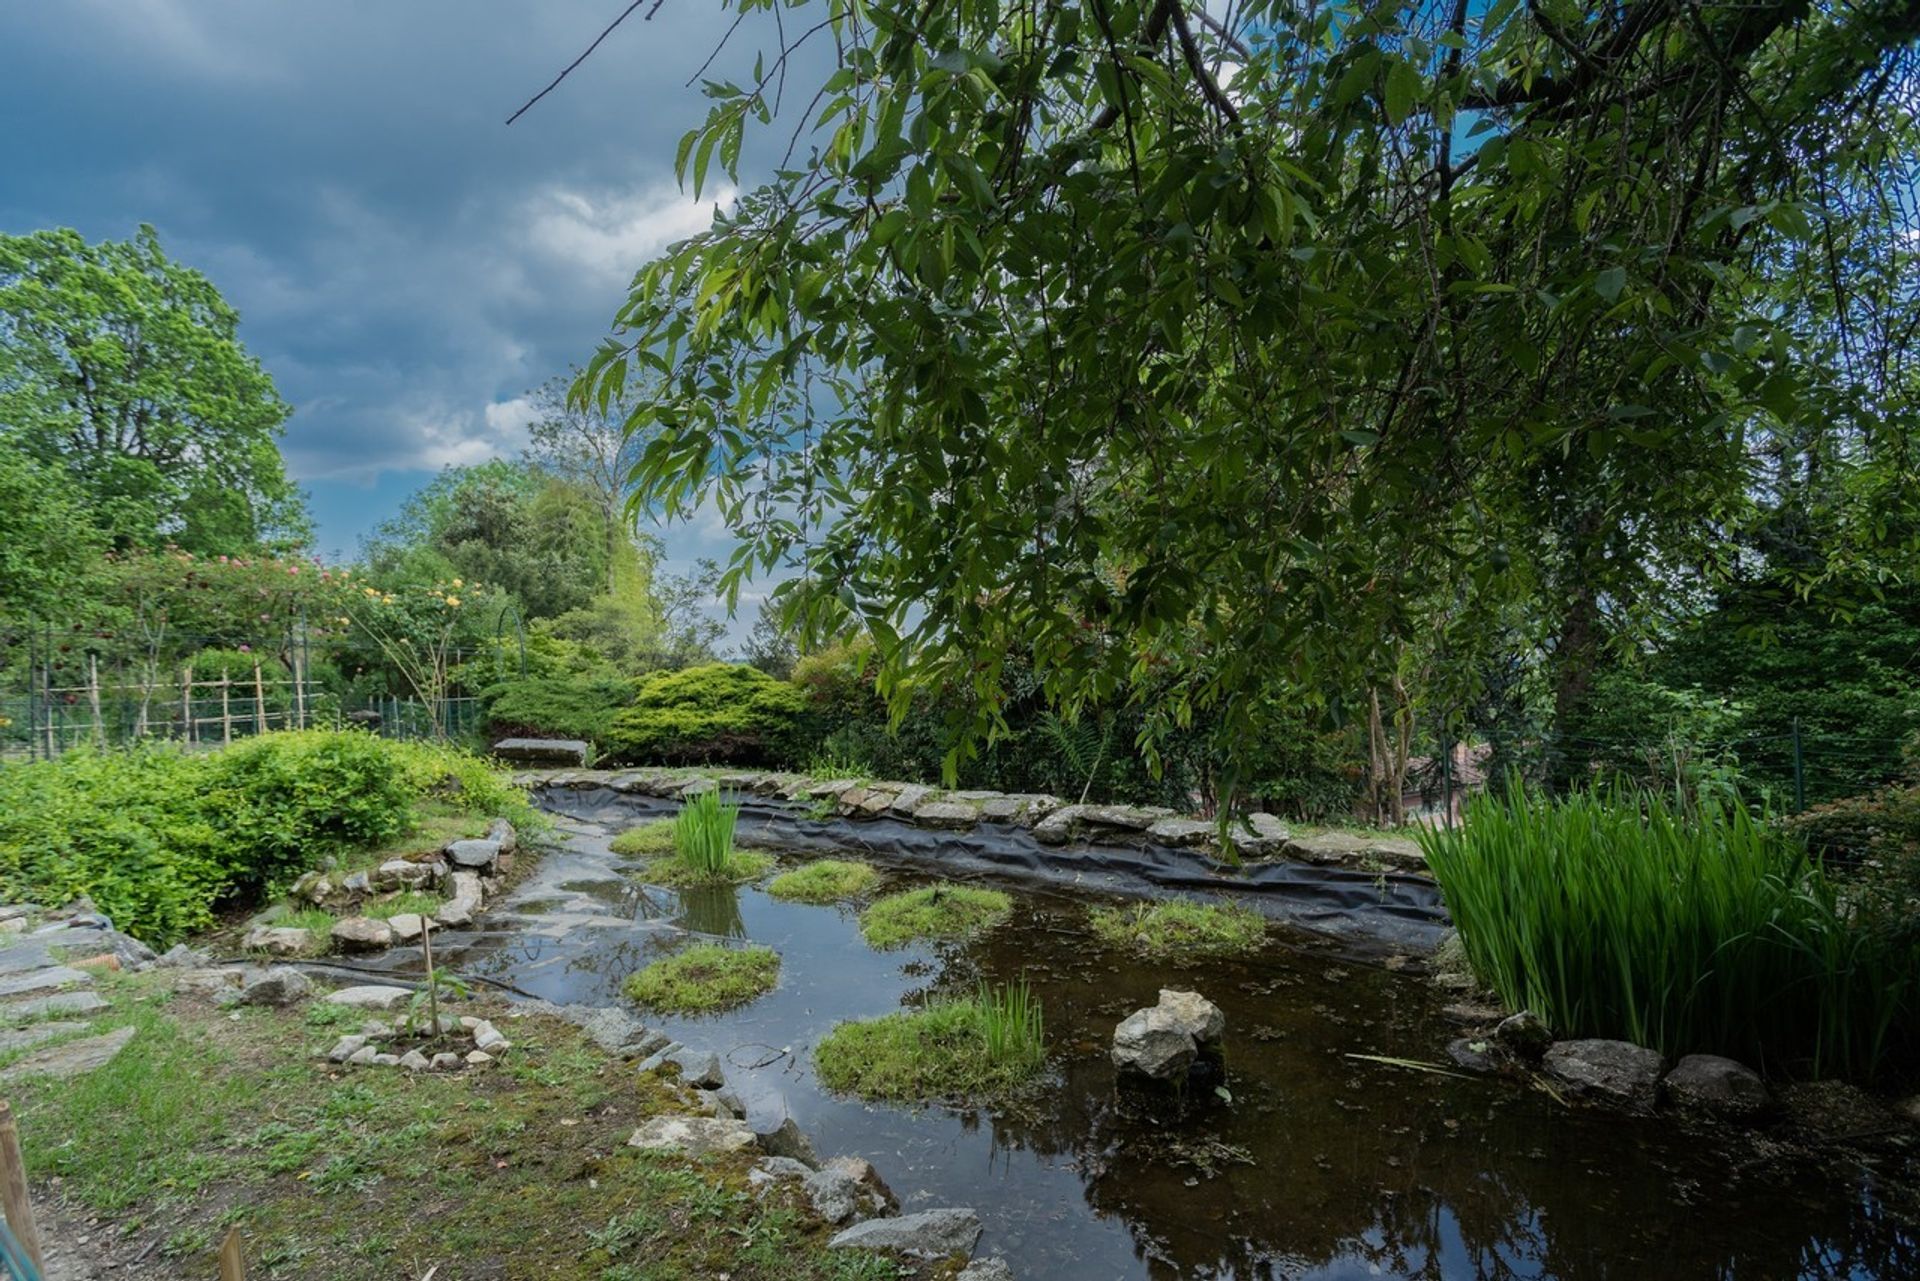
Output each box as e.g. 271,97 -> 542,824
1421,789 -> 1920,1077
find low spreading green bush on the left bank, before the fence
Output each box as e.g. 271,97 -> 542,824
0,730 -> 532,947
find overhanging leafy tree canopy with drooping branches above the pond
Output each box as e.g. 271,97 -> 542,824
578,0 -> 1920,787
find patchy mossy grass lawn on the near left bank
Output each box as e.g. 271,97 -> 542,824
10,972 -> 899,1281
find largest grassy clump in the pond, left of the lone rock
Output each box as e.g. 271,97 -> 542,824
814,983 -> 1046,1102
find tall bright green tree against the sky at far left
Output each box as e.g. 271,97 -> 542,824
0,227 -> 307,555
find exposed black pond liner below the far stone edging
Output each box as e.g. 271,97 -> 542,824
534,787 -> 1450,953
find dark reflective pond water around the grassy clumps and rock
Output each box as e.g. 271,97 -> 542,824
459,801 -> 1920,1281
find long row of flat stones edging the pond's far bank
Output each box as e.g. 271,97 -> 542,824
513,768 -> 1427,876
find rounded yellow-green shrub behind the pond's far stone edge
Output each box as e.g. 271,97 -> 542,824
605,663 -> 804,764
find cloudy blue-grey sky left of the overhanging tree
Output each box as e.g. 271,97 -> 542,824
0,0 -> 787,637
